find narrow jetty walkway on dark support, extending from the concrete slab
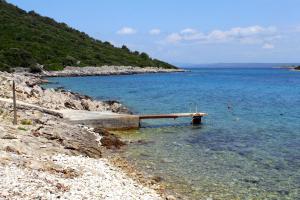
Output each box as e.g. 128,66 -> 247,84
139,113 -> 207,125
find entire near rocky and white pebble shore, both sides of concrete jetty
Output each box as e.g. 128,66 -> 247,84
0,72 -> 169,199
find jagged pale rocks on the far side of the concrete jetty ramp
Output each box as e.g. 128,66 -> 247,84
0,72 -> 129,113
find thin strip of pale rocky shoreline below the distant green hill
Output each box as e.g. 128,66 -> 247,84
42,66 -> 185,77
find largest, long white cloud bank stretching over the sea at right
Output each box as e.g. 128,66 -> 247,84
166,25 -> 280,44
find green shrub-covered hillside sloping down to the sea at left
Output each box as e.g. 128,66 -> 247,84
0,0 -> 175,72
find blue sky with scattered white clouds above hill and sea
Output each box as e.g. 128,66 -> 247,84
8,0 -> 300,64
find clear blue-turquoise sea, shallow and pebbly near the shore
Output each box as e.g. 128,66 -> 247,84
49,68 -> 300,199
